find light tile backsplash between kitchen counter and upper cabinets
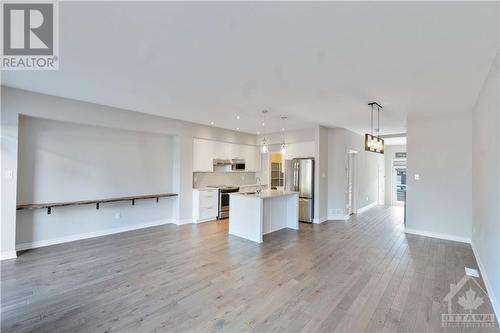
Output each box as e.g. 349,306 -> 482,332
193,172 -> 256,188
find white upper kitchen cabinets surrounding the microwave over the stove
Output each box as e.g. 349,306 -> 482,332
193,139 -> 260,172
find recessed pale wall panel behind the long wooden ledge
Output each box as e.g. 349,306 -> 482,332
16,116 -> 175,249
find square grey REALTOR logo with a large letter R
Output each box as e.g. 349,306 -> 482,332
1,1 -> 59,70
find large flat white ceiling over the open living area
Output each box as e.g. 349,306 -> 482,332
2,2 -> 499,134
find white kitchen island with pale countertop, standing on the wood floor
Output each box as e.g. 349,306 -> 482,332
229,190 -> 299,243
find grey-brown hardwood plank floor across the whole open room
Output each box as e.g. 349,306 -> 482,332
1,207 -> 499,333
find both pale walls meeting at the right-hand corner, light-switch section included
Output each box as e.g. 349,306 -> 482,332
407,53 -> 500,316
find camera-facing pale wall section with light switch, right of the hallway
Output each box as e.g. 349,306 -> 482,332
406,113 -> 472,242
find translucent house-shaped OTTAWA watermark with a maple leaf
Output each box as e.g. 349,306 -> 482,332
441,275 -> 496,328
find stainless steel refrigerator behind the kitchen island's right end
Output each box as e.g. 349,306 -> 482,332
285,158 -> 314,223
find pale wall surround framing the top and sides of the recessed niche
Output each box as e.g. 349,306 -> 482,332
1,86 -> 256,258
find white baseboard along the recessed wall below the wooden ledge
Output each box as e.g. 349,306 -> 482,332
15,219 -> 174,249
